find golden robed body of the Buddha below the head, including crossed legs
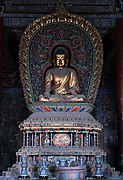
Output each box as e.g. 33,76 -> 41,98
39,67 -> 85,101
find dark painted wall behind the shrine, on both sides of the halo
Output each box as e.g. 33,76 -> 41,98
0,0 -> 123,174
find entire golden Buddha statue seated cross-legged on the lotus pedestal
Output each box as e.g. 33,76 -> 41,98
39,46 -> 85,102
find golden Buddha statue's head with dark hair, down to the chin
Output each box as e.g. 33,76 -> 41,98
53,46 -> 69,67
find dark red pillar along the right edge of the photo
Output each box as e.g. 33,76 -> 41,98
116,19 -> 123,162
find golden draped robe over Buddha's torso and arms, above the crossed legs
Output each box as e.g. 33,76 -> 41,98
45,68 -> 80,94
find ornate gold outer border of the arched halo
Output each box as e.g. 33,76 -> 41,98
19,9 -> 103,106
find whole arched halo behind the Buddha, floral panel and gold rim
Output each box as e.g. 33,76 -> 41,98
19,8 -> 103,110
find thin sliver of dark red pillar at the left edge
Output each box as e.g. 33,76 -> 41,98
0,17 -> 3,99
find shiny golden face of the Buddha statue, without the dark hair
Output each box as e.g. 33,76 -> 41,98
56,54 -> 66,67
